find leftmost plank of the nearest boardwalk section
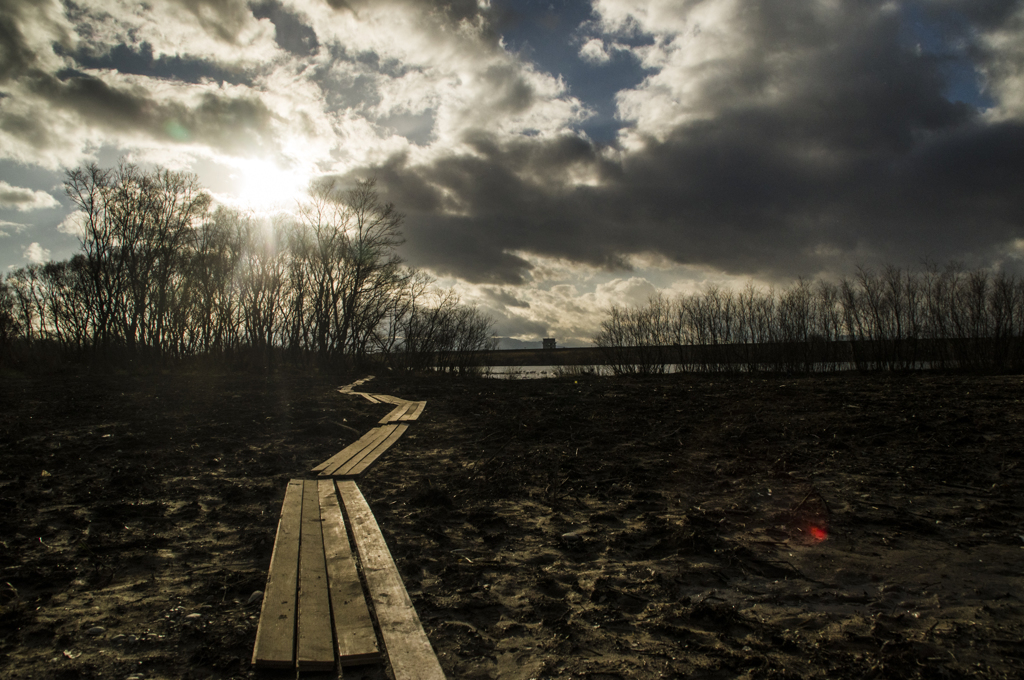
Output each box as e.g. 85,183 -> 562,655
253,479 -> 302,668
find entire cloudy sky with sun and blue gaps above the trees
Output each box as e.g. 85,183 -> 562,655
0,0 -> 1024,347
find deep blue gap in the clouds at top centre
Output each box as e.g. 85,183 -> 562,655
490,0 -> 651,142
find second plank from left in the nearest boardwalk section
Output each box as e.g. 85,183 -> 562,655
295,479 -> 334,671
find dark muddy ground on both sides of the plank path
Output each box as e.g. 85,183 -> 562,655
0,372 -> 1024,680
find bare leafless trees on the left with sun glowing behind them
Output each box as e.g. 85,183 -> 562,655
0,163 -> 493,371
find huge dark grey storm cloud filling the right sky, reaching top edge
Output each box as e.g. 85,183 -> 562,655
356,2 -> 1024,284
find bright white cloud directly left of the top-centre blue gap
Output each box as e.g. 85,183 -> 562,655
295,0 -> 589,154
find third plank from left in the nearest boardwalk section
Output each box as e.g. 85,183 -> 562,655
318,479 -> 381,666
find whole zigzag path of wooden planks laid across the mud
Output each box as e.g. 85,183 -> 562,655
253,376 -> 444,680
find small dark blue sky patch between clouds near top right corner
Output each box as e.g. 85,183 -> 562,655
901,2 -> 994,110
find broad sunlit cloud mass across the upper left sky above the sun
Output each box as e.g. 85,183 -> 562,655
0,0 -> 589,179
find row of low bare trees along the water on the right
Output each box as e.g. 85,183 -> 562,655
595,264 -> 1024,374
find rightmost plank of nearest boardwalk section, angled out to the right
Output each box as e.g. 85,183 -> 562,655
337,481 -> 444,680
